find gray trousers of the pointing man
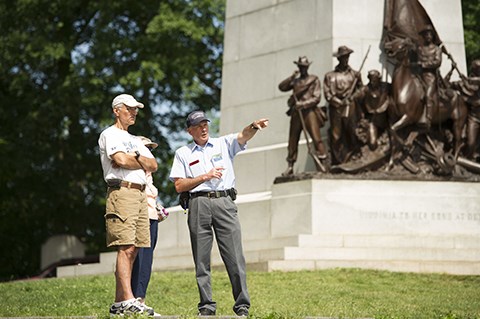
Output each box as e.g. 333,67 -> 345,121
188,197 -> 250,312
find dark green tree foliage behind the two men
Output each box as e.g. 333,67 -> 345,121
0,0 -> 224,279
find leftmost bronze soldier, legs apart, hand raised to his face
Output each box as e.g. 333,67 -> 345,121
278,56 -> 327,176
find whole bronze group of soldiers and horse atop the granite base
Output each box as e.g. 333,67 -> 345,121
278,29 -> 480,177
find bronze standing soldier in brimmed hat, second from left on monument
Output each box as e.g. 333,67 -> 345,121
323,46 -> 362,164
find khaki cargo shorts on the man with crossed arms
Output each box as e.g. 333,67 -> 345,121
105,187 -> 150,247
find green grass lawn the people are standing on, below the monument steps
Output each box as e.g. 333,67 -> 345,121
0,269 -> 480,319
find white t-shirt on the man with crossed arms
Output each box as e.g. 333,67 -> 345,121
98,125 -> 153,184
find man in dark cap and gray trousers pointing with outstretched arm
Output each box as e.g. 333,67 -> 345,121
170,111 -> 268,316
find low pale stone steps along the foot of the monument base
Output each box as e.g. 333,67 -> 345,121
57,235 -> 480,277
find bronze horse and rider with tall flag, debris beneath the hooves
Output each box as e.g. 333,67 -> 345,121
382,0 -> 467,174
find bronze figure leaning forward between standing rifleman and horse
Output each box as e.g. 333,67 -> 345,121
354,70 -> 392,150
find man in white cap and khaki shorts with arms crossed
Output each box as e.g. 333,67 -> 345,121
98,94 -> 157,315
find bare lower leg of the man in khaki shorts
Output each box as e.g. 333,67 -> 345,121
115,245 -> 137,302
